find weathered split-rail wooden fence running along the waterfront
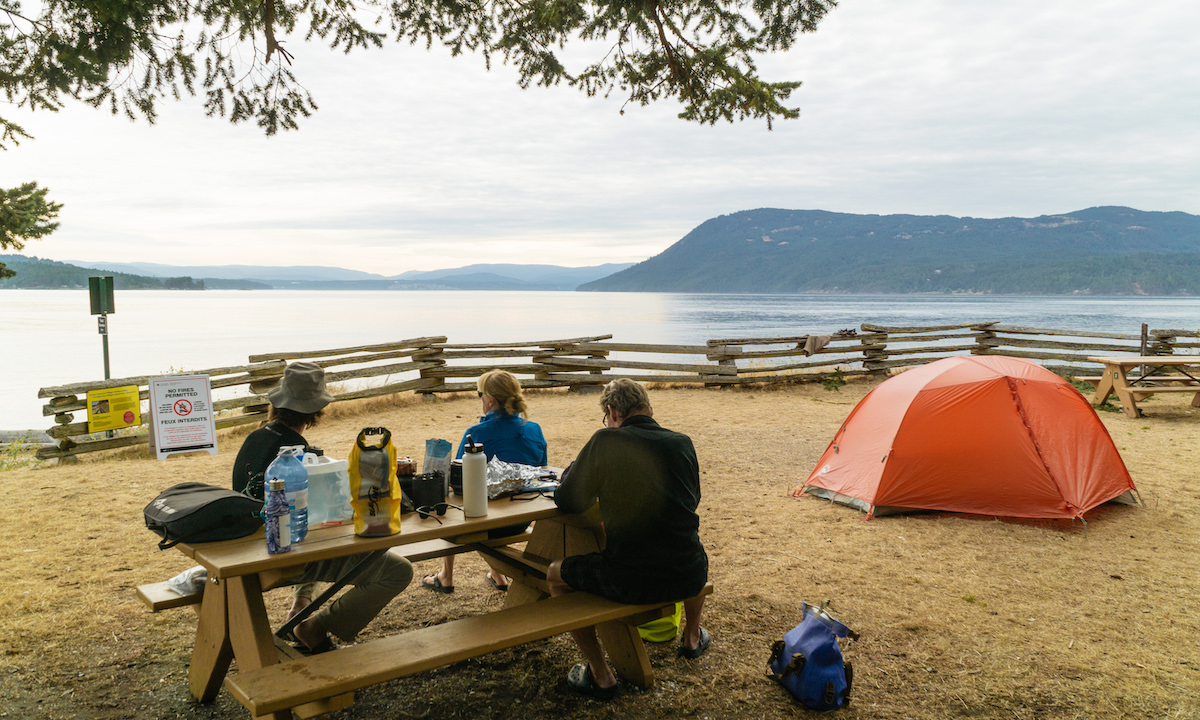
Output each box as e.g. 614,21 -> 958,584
37,320 -> 1200,458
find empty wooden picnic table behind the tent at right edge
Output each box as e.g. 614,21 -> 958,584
1088,355 -> 1200,418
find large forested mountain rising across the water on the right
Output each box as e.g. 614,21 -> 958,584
580,206 -> 1200,295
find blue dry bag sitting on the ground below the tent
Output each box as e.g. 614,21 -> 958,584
767,602 -> 858,710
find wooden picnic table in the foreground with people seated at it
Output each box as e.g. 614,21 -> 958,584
166,496 -> 696,720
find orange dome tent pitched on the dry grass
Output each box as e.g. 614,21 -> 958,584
802,355 -> 1136,518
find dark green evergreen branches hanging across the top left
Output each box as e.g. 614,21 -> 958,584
0,0 -> 836,277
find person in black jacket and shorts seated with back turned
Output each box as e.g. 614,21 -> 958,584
546,378 -> 712,700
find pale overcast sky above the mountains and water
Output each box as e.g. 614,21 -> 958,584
0,0 -> 1200,275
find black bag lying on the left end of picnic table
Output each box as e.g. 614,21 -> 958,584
142,482 -> 263,550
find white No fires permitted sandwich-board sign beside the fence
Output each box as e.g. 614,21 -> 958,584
150,376 -> 217,460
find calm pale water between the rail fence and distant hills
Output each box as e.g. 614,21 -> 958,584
0,289 -> 1200,430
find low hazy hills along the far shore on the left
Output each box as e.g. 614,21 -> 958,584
0,254 -> 632,290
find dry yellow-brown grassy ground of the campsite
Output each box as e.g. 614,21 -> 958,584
0,383 -> 1200,720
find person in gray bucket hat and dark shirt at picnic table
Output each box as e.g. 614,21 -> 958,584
233,362 -> 413,653
